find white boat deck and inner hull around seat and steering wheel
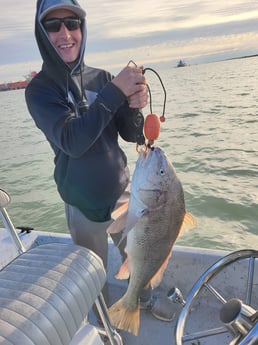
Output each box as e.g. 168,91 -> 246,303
0,229 -> 258,345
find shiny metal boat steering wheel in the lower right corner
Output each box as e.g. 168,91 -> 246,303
175,250 -> 258,345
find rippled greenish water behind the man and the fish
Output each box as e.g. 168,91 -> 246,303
0,57 -> 258,250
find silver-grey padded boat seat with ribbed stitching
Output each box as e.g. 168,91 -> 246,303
0,243 -> 106,345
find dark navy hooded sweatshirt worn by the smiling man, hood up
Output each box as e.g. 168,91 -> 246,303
25,0 -> 142,222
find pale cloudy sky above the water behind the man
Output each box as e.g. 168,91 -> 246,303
0,0 -> 258,83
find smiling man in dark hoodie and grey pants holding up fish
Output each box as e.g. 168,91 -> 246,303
25,0 -> 175,322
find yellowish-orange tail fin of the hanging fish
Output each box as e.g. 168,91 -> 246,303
108,298 -> 140,335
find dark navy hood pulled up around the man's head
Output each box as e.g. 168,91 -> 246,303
35,0 -> 86,89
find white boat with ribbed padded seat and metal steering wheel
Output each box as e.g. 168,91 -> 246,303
0,189 -> 258,345
